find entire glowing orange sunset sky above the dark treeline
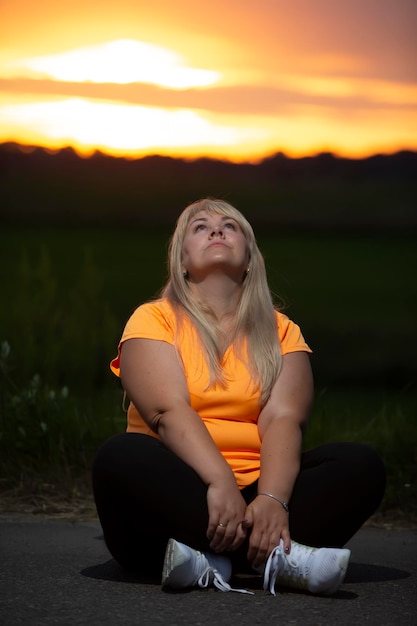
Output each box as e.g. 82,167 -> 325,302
0,0 -> 417,161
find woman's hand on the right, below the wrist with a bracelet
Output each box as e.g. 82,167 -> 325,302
243,496 -> 291,568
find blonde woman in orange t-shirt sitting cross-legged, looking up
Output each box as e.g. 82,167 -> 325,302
93,199 -> 385,594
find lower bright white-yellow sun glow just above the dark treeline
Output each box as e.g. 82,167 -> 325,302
0,98 -> 256,153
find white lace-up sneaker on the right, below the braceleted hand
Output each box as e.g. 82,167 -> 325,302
264,539 -> 350,596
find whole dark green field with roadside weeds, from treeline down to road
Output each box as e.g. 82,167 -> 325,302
0,226 -> 417,510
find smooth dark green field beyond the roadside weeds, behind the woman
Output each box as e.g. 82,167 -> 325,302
0,227 -> 417,390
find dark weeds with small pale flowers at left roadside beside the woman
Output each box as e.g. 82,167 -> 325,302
0,341 -> 124,493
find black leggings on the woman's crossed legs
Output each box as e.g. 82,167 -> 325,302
93,433 -> 385,575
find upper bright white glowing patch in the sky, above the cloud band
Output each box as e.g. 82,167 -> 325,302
9,39 -> 221,89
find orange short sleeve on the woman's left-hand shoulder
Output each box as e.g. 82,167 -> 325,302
110,301 -> 175,376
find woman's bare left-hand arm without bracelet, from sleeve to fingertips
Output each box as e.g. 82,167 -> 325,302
120,339 -> 246,551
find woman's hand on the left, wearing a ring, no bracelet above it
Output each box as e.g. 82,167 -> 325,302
207,479 -> 247,552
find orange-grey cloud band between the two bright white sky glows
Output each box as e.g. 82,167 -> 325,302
0,77 -> 417,116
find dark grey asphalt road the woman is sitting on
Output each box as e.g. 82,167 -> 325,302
0,517 -> 417,626
